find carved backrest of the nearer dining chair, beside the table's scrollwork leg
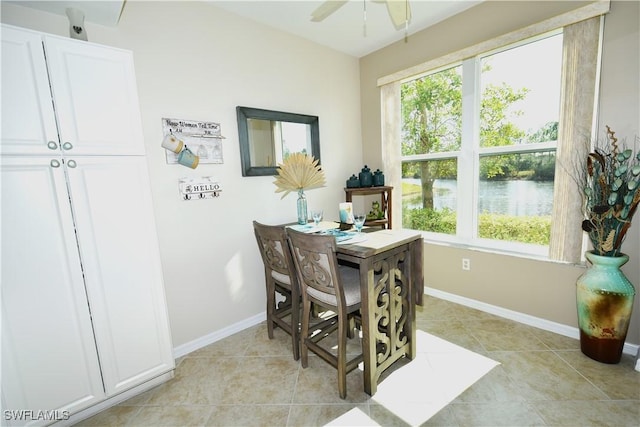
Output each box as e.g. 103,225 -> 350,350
287,229 -> 345,306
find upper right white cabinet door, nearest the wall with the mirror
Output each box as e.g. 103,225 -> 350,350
44,36 -> 145,155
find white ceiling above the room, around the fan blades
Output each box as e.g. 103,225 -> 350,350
10,0 -> 483,57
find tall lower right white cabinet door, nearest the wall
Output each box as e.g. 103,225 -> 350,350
68,156 -> 174,394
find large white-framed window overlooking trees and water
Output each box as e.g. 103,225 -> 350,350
400,31 -> 563,254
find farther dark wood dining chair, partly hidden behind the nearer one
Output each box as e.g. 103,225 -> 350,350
253,221 -> 300,360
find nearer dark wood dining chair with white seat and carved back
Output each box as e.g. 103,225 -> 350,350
287,229 -> 362,399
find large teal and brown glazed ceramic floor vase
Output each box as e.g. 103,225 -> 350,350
576,251 -> 636,363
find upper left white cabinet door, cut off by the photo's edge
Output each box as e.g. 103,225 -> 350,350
0,25 -> 58,154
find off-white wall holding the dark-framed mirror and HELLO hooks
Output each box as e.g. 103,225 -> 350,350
2,1 -> 362,347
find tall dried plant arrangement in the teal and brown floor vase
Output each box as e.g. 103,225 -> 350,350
582,126 -> 640,257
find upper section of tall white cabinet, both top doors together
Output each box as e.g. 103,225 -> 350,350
2,26 -> 145,156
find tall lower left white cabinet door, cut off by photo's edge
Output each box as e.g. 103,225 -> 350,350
1,156 -> 104,419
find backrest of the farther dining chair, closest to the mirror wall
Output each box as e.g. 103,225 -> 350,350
253,221 -> 297,285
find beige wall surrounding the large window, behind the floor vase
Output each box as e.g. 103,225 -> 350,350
360,1 -> 640,344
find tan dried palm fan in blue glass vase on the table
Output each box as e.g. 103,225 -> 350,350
273,153 -> 325,224
